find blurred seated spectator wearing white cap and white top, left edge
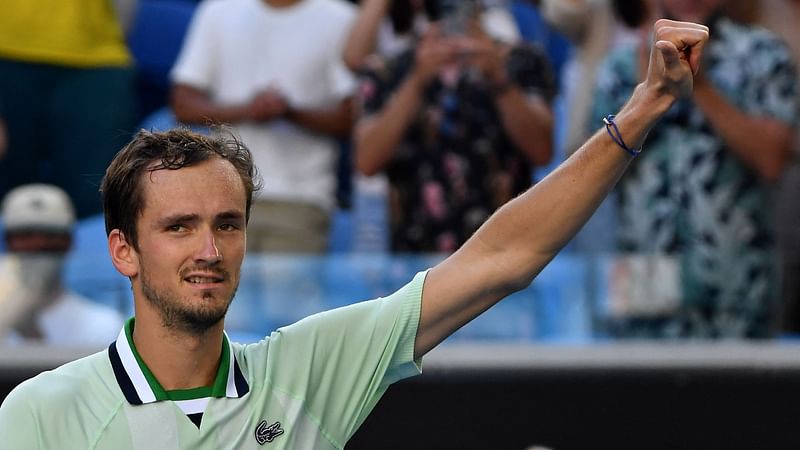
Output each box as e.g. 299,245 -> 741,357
0,184 -> 123,346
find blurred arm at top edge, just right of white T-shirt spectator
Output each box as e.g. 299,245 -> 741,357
342,0 -> 392,71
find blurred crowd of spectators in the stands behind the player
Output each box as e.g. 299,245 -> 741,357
0,0 -> 800,347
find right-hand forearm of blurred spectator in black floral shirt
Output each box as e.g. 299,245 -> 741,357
496,86 -> 553,166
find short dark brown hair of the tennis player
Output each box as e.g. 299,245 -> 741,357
100,127 -> 261,250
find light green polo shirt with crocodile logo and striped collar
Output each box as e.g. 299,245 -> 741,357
0,272 -> 425,450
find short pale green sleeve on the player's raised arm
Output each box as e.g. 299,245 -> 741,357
260,273 -> 425,445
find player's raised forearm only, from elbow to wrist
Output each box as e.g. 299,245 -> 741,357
465,86 -> 669,286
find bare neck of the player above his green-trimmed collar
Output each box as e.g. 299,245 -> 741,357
133,307 -> 224,391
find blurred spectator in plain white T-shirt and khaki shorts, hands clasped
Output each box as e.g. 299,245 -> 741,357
172,0 -> 356,253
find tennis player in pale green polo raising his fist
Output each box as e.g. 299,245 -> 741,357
0,20 -> 708,450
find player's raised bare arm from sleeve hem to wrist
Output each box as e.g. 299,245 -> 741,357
415,86 -> 671,356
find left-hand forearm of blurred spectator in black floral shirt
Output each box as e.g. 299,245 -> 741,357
355,75 -> 423,175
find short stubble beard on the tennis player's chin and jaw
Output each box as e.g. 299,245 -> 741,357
142,273 -> 239,336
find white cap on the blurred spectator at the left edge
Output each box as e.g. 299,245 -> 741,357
2,184 -> 75,232
